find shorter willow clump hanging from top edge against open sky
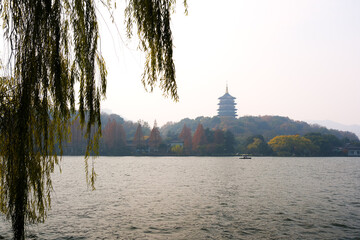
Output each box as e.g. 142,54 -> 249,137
125,0 -> 187,101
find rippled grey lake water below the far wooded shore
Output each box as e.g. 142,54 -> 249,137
0,157 -> 360,239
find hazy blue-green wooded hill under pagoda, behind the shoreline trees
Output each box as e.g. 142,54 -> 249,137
160,116 -> 359,141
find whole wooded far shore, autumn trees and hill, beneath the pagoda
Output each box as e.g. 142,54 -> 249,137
63,113 -> 360,156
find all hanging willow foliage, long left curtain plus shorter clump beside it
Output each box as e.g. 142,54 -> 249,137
0,0 -> 186,239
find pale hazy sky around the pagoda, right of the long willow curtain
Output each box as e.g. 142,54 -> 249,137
97,0 -> 360,125
